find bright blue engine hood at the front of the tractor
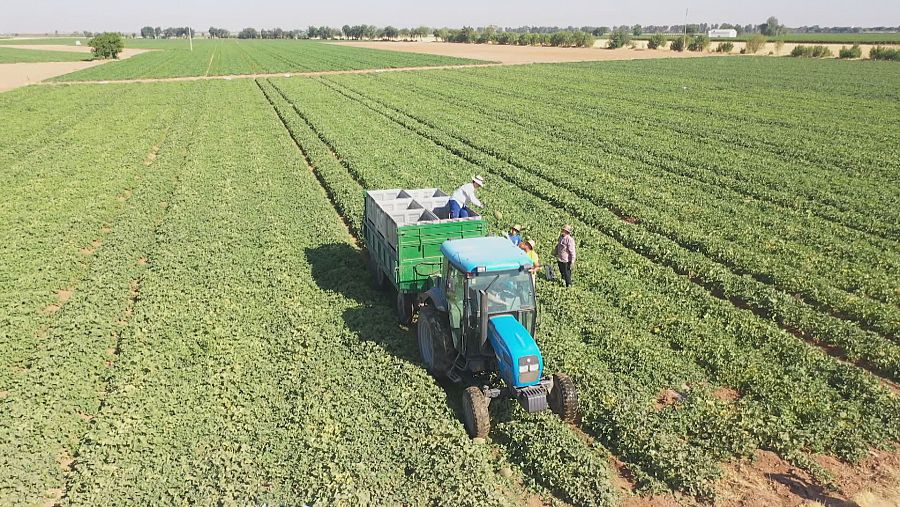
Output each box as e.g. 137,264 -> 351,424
488,315 -> 544,388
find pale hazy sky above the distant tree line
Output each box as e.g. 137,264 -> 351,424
0,0 -> 900,33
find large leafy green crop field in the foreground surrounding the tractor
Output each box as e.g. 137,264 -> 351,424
0,53 -> 900,505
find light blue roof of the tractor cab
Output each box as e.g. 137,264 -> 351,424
441,236 -> 532,273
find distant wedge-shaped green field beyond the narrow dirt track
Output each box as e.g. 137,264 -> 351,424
49,39 -> 483,81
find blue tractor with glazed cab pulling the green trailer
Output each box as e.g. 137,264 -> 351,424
417,237 -> 578,438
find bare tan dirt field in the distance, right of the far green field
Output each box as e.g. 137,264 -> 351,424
334,41 -> 710,65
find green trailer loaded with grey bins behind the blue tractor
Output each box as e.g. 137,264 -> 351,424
363,188 -> 487,324
